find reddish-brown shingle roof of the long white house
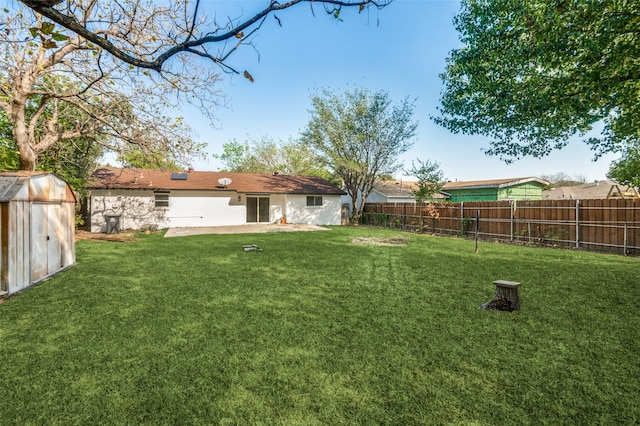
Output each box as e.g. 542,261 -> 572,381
87,167 -> 345,195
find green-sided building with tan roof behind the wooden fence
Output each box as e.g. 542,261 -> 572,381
442,177 -> 549,203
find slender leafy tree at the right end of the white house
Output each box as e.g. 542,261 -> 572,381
302,88 -> 418,223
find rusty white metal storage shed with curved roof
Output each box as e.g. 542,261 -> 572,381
0,171 -> 76,295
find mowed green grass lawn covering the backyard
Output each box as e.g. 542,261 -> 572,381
0,227 -> 640,425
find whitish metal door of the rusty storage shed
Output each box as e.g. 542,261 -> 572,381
31,203 -> 62,281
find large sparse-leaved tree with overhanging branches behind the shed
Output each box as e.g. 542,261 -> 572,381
6,0 -> 391,170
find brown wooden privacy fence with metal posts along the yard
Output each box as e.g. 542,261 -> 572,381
361,199 -> 640,256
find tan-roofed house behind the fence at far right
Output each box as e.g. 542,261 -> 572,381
542,180 -> 638,200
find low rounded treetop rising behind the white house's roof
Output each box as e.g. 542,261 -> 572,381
213,137 -> 331,179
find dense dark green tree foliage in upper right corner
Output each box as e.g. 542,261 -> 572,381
434,0 -> 640,162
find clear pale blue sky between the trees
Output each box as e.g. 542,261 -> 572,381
182,0 -> 616,180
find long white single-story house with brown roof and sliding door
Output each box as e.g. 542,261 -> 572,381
87,167 -> 344,233
